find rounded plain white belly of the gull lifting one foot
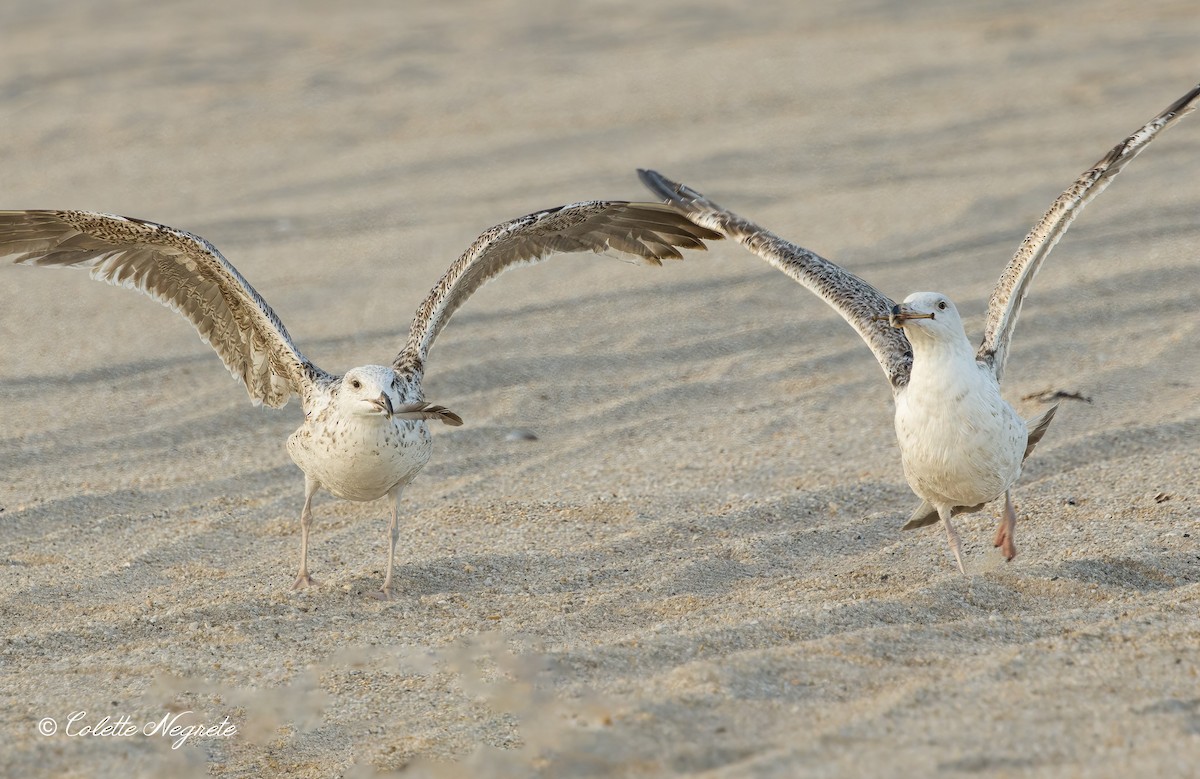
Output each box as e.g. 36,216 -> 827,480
895,371 -> 1028,505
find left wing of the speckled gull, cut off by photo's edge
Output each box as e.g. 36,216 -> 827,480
0,211 -> 326,407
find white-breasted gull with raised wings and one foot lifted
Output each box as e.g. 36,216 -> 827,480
638,85 -> 1200,574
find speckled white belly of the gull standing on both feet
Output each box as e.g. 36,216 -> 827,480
288,417 -> 433,501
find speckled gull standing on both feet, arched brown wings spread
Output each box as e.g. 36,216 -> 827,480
0,200 -> 720,590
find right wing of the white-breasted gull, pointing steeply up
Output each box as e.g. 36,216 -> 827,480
976,84 -> 1200,379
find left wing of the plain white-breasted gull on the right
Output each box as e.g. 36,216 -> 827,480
637,170 -> 912,391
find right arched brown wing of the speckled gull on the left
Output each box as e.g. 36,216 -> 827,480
394,200 -> 721,373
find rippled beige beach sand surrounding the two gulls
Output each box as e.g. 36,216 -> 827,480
0,0 -> 1200,777
